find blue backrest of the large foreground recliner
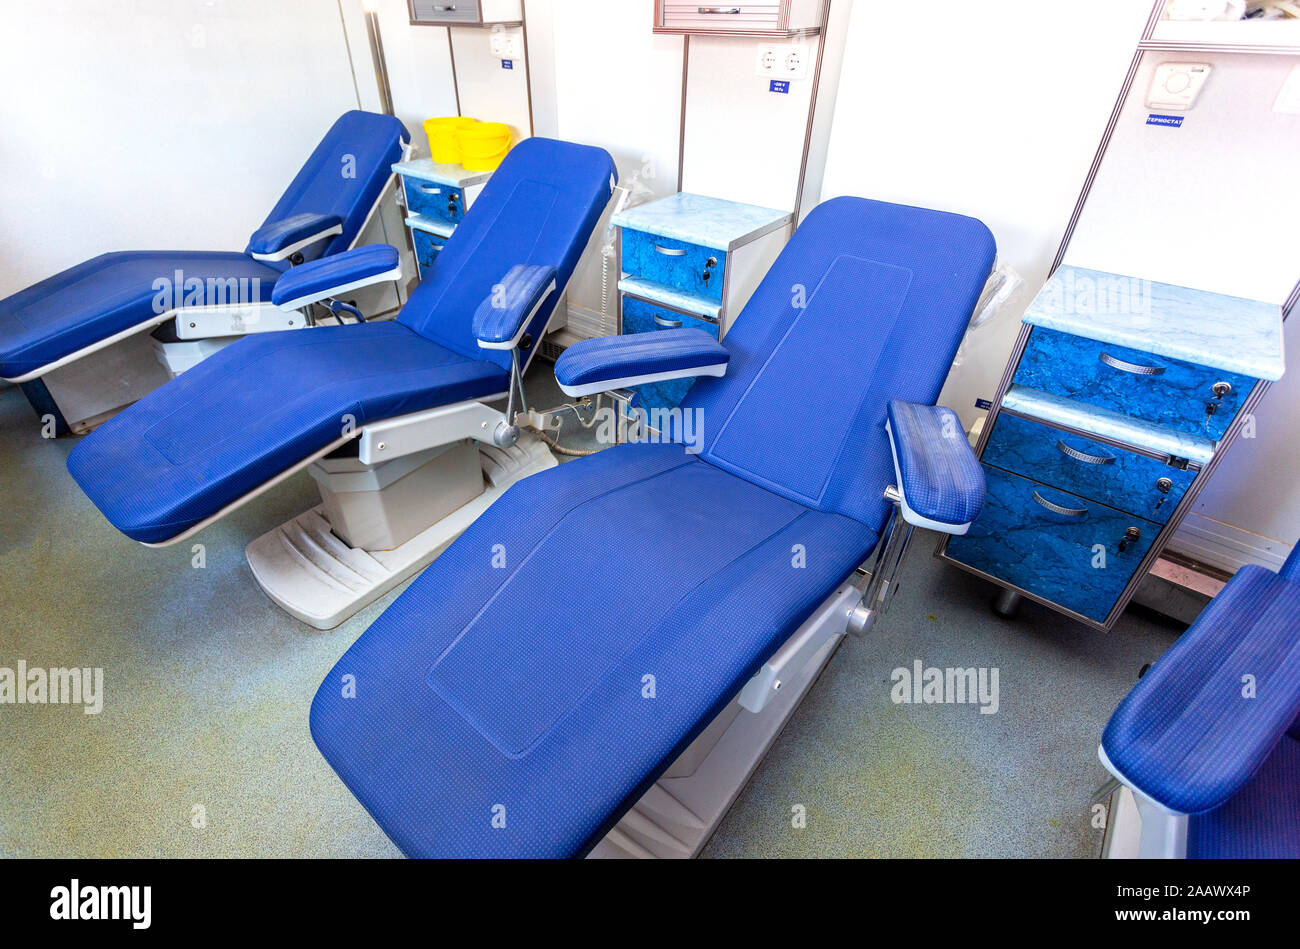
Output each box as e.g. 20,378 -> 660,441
683,198 -> 996,530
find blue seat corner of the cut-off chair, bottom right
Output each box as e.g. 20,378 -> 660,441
1187,737 -> 1300,859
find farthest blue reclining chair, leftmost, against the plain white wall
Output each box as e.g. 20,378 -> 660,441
0,111 -> 411,430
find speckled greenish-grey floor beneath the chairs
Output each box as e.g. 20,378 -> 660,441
0,367 -> 1173,857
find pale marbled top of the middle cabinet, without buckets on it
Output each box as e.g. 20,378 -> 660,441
614,191 -> 793,251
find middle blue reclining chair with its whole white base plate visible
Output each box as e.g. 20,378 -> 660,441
68,138 -> 616,628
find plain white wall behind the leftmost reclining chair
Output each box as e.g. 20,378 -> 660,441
0,0 -> 356,295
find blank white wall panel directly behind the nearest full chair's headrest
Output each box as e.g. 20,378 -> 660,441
822,0 -> 1151,425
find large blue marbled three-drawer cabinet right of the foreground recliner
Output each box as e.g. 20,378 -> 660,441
940,267 -> 1283,629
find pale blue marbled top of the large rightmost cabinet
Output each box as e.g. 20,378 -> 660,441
1024,265 -> 1286,382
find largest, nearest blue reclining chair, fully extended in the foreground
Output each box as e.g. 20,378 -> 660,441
311,198 -> 995,858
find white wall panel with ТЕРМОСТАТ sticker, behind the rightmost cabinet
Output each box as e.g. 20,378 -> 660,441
1066,53 -> 1300,569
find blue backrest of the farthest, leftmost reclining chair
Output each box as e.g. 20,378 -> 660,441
244,109 -> 411,269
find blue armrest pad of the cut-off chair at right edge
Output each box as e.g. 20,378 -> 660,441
1101,564 -> 1300,814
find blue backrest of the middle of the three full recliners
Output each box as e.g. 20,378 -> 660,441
398,138 -> 618,367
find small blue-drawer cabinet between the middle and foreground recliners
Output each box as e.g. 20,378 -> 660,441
614,192 -> 793,411
